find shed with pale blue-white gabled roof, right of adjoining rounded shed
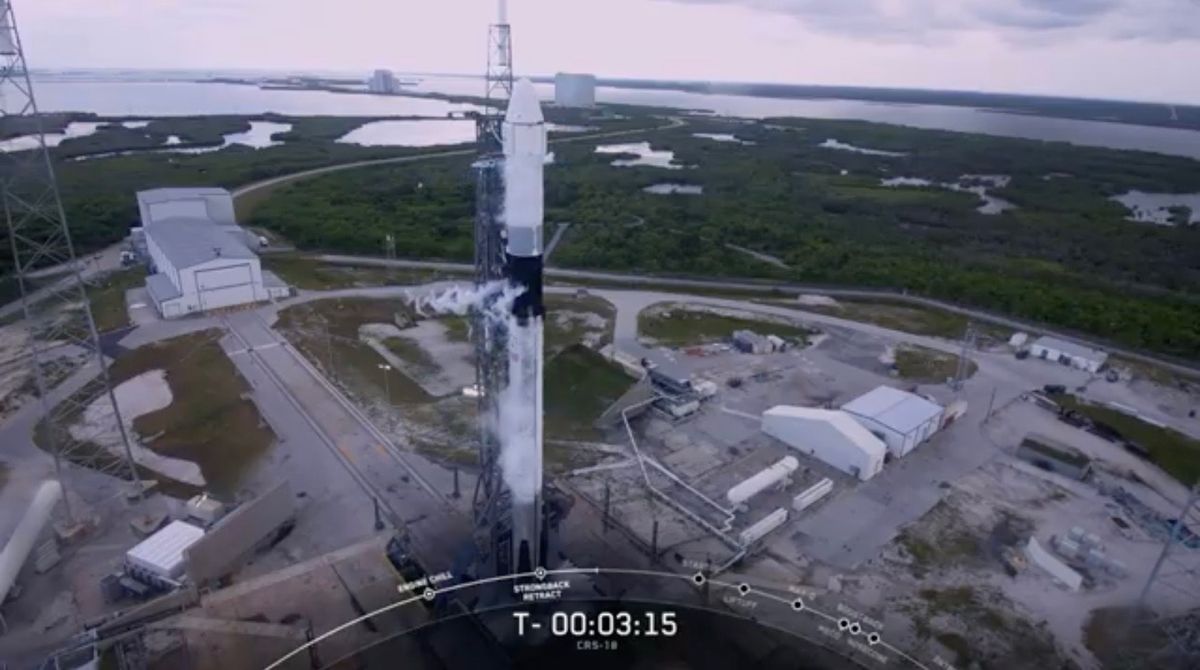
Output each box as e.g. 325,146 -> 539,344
841,387 -> 944,457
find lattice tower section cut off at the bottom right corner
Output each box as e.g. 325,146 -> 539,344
1123,481 -> 1200,670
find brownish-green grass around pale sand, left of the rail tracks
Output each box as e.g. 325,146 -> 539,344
34,330 -> 275,496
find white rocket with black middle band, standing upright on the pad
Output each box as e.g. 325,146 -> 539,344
499,79 -> 546,572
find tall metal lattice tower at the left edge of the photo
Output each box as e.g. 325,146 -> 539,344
0,0 -> 138,522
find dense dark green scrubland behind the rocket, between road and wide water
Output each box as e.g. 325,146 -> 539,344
248,114 -> 1200,358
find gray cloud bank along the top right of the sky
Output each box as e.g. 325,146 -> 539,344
660,0 -> 1200,42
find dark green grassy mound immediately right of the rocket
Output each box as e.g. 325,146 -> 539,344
545,345 -> 634,439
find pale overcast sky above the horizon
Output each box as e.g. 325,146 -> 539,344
13,0 -> 1200,103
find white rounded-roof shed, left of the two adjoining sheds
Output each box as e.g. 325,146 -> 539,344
762,405 -> 887,481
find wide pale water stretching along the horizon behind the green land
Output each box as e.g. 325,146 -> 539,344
16,74 -> 1200,158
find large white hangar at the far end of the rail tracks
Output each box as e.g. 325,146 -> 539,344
138,189 -> 290,318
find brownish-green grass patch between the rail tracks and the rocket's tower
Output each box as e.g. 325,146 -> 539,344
275,298 -> 431,405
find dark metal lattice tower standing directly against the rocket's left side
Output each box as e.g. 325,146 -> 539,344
472,0 -> 514,574
